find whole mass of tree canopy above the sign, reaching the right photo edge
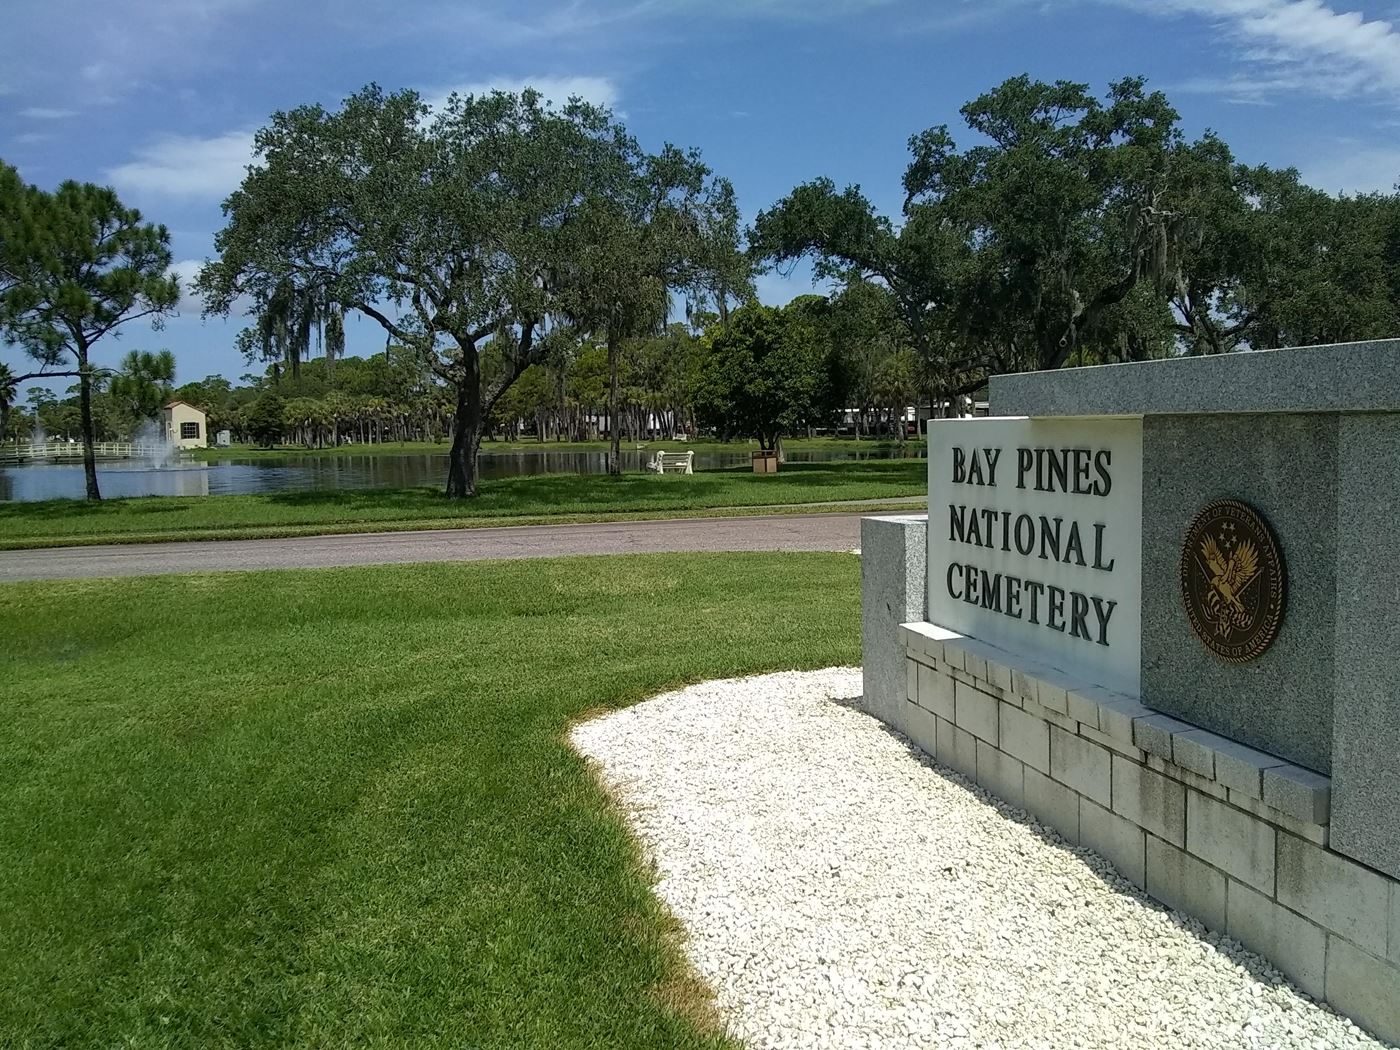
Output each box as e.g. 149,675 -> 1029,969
750,76 -> 1400,400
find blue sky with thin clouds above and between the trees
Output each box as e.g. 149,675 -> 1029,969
0,0 -> 1400,381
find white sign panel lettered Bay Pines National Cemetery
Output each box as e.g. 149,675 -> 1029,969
928,417 -> 1142,696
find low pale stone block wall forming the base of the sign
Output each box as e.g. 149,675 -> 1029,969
886,623 -> 1400,1042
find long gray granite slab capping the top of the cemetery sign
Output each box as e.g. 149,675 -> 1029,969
991,339 -> 1400,416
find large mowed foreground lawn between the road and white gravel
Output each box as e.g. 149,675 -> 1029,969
0,554 -> 860,1047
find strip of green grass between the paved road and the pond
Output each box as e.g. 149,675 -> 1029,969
0,459 -> 928,550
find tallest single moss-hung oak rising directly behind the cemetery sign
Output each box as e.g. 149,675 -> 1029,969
750,77 -> 1271,396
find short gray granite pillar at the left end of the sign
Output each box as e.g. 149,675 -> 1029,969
861,514 -> 928,731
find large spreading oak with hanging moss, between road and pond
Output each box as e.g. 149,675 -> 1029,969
199,85 -> 748,496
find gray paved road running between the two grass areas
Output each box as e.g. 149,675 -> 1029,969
0,508 -> 879,581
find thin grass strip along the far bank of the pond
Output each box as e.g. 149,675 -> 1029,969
193,437 -> 923,461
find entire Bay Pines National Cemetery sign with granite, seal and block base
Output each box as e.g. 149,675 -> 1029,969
861,340 -> 1400,1040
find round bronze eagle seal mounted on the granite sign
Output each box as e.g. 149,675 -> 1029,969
1182,500 -> 1287,664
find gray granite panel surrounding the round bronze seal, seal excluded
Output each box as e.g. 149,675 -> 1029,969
1142,414 -> 1338,773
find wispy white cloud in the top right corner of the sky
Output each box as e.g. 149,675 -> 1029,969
1127,0 -> 1400,102
